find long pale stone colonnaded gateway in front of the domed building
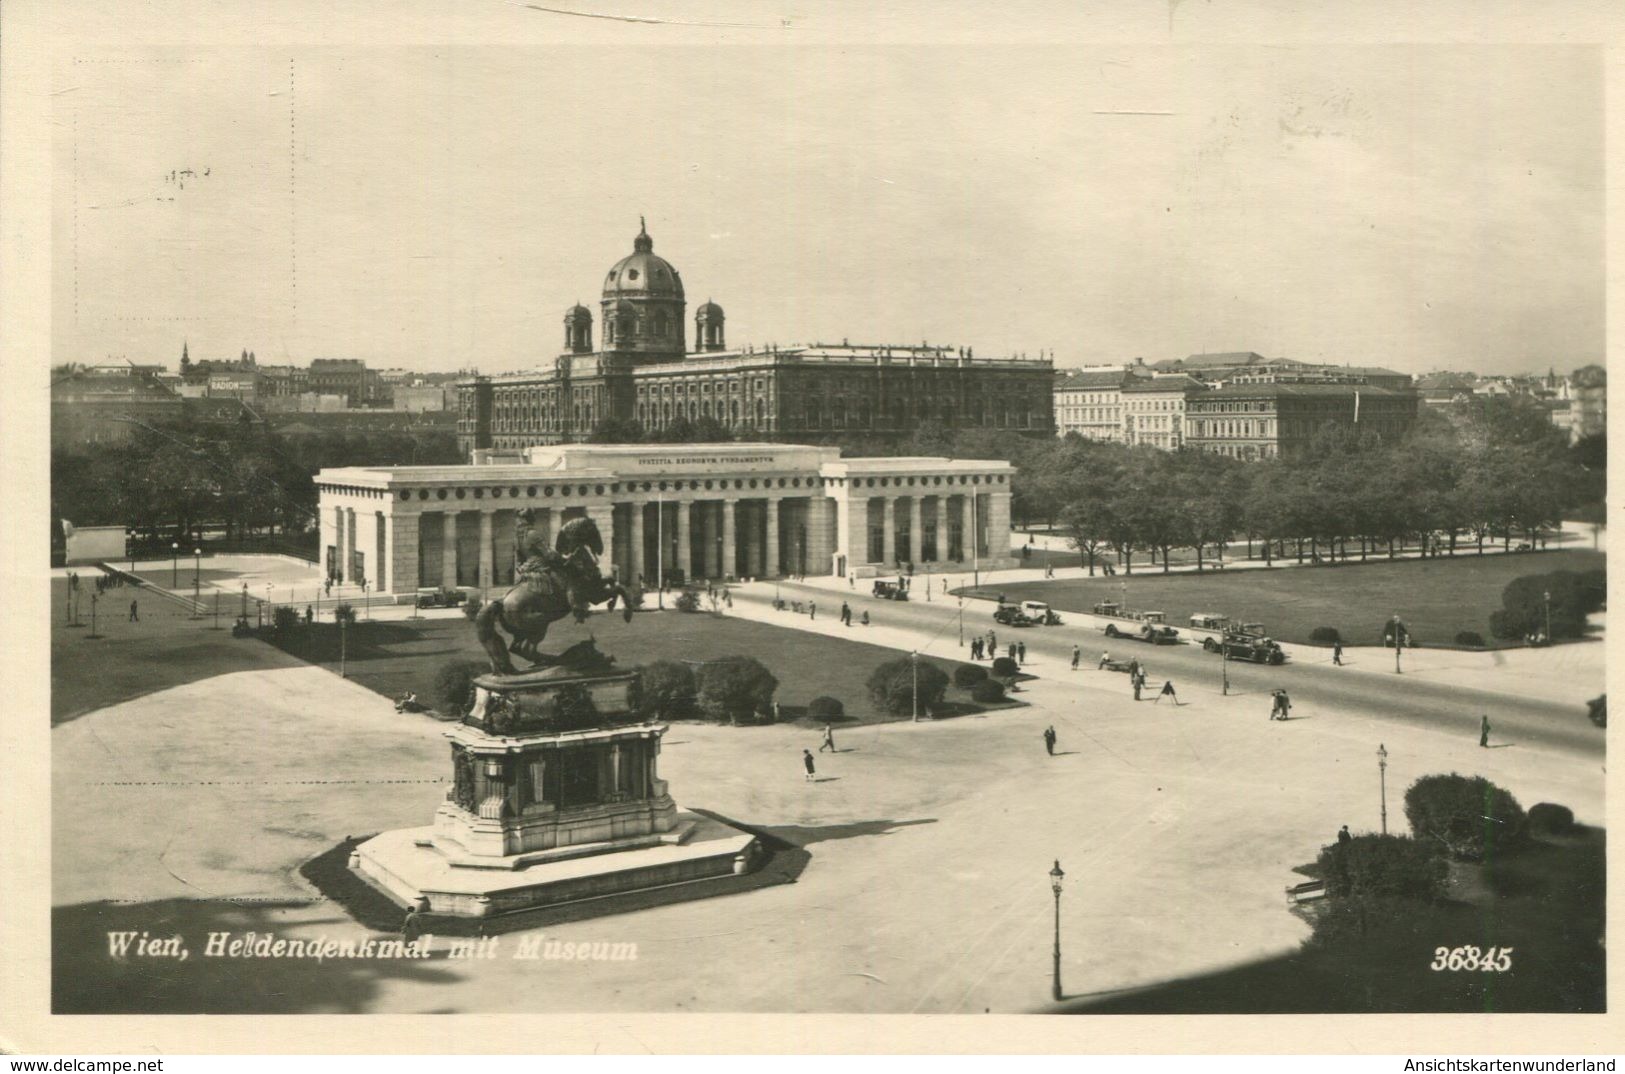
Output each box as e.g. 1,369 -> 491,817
315,444 -> 1014,593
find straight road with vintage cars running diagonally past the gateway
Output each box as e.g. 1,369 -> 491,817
754,583 -> 1606,759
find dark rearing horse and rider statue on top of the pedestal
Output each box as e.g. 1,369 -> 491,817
475,510 -> 632,674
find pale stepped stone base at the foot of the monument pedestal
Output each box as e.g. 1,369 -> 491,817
351,812 -> 761,918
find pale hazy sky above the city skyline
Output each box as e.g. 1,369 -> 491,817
52,41 -> 1604,374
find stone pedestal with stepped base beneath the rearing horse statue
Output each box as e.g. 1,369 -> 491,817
353,656 -> 757,916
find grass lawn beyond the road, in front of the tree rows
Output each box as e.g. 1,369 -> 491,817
977,549 -> 1607,647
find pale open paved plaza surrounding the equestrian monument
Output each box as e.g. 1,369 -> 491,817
52,539 -> 1604,1012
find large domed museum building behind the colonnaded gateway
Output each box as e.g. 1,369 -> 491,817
457,219 -> 1055,455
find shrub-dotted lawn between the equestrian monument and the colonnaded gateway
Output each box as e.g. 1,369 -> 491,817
256,611 -> 1019,723
